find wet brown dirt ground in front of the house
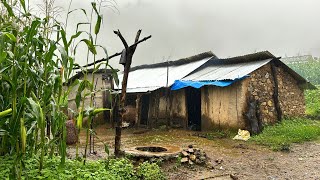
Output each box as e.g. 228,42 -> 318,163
68,125 -> 320,180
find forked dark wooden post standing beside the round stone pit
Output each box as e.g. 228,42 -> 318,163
113,30 -> 151,157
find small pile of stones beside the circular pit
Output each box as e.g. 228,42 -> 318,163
180,145 -> 208,165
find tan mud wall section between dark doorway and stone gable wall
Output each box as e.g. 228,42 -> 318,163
201,79 -> 249,130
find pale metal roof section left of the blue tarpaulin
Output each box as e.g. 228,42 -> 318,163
116,53 -> 213,92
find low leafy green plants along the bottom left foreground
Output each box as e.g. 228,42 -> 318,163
0,156 -> 165,180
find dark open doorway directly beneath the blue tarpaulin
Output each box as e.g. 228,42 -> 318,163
186,87 -> 201,131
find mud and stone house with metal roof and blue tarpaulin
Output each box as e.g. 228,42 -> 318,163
116,51 -> 315,133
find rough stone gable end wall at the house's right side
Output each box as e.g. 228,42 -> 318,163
248,63 -> 305,124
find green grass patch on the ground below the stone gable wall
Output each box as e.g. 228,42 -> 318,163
251,118 -> 320,151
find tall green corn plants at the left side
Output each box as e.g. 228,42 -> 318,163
0,0 -> 112,179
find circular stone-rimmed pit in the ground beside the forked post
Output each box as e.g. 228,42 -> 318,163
124,145 -> 182,159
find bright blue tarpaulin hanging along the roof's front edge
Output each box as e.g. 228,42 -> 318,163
171,76 -> 248,90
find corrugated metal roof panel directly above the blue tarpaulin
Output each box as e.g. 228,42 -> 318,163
182,59 -> 272,81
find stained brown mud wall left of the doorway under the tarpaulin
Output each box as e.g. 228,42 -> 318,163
149,88 -> 187,127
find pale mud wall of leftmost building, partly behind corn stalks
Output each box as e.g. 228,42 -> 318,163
68,73 -> 111,124
